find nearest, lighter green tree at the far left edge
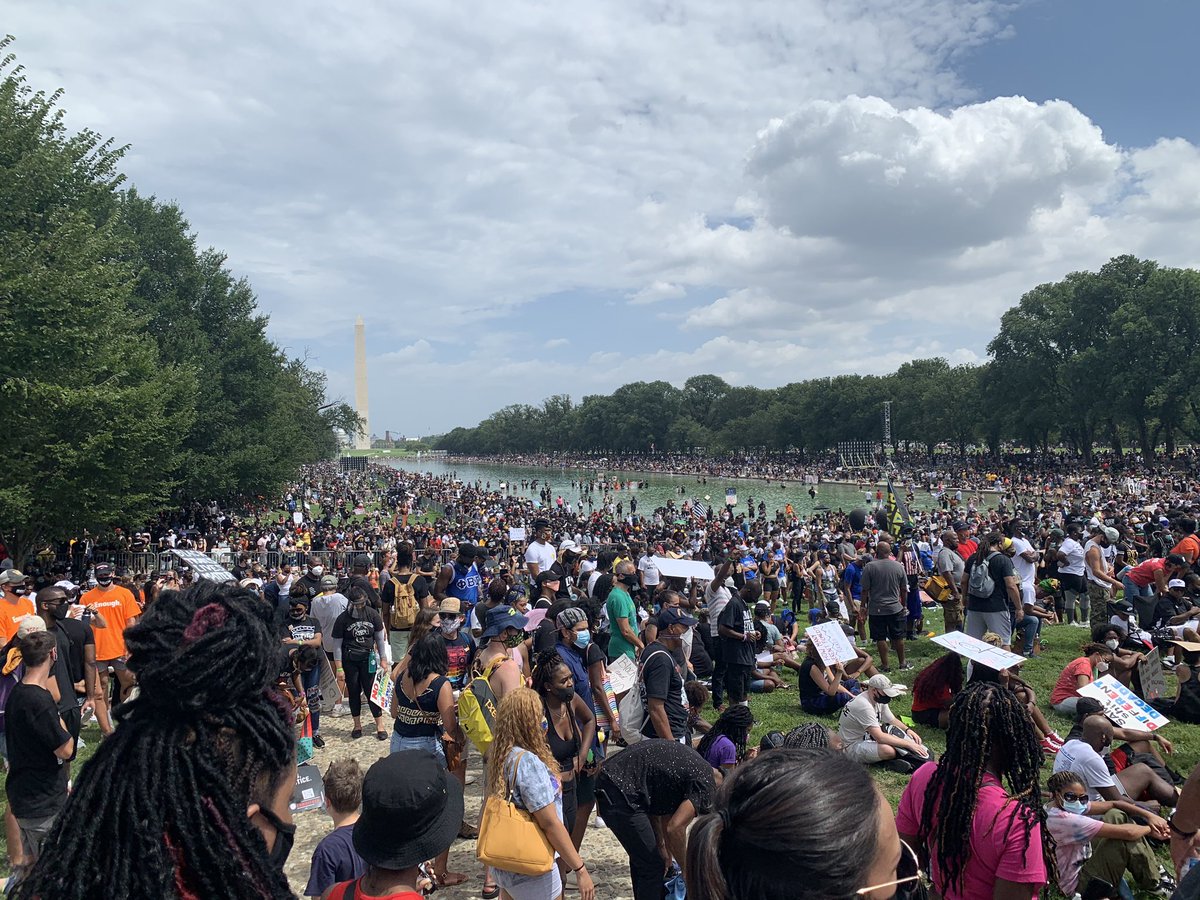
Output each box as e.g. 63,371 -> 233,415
0,49 -> 196,562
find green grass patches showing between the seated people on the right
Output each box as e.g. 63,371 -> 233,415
739,610 -> 1200,898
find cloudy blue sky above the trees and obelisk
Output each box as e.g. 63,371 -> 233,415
9,0 -> 1200,436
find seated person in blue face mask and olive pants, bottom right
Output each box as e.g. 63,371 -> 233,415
1046,770 -> 1175,896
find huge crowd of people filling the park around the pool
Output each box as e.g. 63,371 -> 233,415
0,461 -> 1200,900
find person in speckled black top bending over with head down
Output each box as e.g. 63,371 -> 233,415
596,740 -> 716,900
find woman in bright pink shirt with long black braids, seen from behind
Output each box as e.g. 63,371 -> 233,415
896,683 -> 1054,900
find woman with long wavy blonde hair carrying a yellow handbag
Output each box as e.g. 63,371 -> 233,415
487,688 -> 592,900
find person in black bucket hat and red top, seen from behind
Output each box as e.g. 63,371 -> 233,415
328,750 -> 463,900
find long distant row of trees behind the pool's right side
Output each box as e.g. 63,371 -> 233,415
437,256 -> 1200,460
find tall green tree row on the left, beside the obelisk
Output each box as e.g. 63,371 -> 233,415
0,44 -> 358,559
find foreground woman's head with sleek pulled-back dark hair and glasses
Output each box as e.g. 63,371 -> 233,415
691,748 -> 920,900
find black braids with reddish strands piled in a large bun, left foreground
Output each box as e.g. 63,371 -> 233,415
17,581 -> 295,900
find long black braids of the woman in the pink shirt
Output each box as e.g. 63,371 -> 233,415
918,682 -> 1055,895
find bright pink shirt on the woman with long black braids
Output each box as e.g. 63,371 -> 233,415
896,763 -> 1046,900
